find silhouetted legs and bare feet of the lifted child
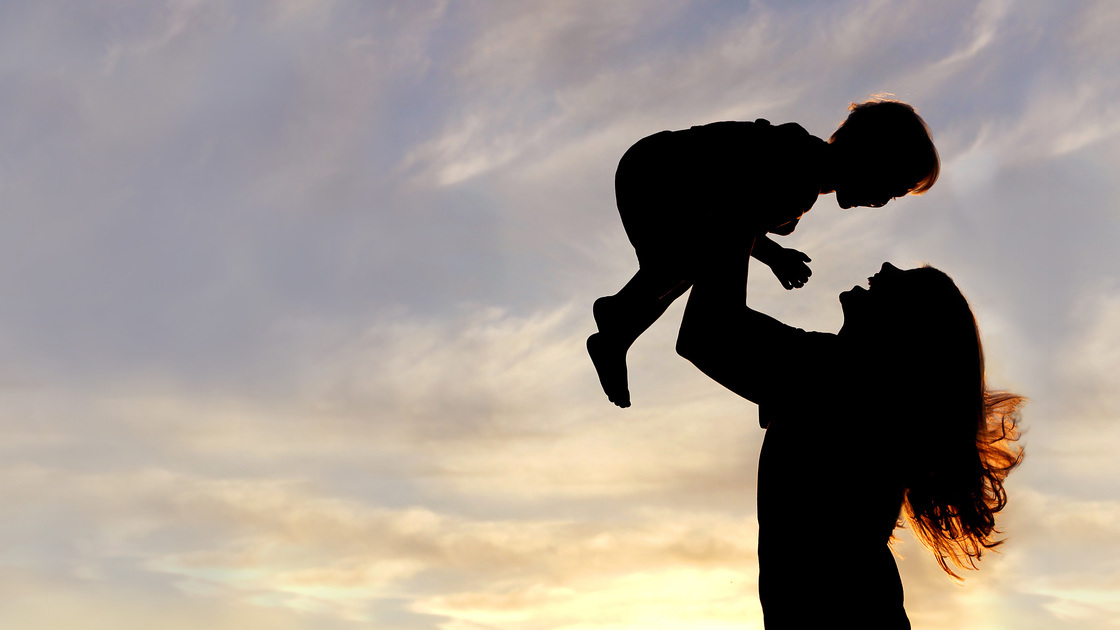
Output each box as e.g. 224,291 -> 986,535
587,268 -> 691,407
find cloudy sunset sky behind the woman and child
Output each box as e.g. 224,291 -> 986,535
0,0 -> 1120,630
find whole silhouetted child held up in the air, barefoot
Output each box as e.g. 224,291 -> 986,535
587,98 -> 940,407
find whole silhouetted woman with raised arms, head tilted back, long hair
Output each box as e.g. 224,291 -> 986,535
678,237 -> 1023,630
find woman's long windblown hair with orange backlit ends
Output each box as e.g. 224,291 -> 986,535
873,267 -> 1024,580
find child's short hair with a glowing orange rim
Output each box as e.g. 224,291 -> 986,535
829,94 -> 941,195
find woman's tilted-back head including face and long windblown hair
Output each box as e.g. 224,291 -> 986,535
841,263 -> 1023,576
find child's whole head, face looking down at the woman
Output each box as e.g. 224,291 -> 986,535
829,95 -> 941,207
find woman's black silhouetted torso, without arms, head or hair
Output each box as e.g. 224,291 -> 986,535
758,333 -> 909,630
